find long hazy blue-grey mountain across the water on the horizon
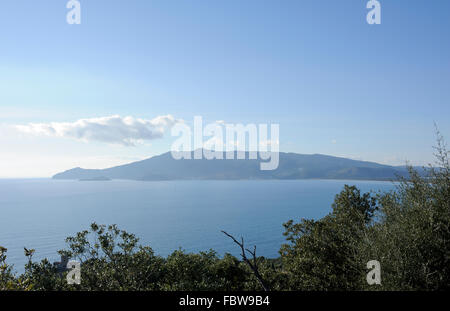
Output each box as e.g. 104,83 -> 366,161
53,152 -> 414,180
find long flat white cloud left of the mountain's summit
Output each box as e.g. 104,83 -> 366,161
16,115 -> 183,146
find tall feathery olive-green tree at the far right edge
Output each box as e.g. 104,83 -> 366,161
368,131 -> 450,290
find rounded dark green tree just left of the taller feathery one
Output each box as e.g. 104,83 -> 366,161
280,185 -> 376,290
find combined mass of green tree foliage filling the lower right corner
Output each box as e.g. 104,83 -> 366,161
280,133 -> 450,290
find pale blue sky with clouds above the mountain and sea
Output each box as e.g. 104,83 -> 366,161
0,0 -> 450,178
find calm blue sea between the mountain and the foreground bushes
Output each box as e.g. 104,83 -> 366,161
0,179 -> 394,272
